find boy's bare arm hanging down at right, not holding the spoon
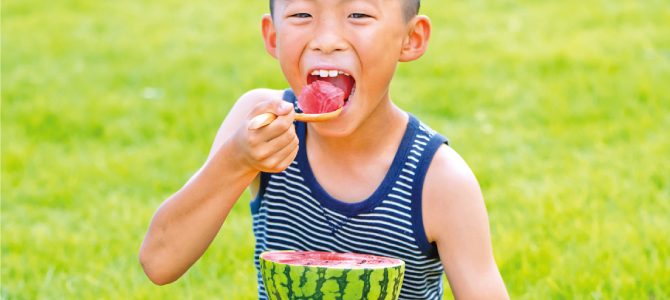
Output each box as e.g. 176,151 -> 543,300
423,146 -> 509,299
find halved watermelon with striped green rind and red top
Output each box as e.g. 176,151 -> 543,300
260,251 -> 405,300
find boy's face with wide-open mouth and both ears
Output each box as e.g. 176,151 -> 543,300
263,0 -> 429,135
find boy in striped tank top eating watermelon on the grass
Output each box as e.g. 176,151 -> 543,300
140,0 -> 508,299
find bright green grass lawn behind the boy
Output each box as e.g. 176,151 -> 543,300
0,0 -> 670,299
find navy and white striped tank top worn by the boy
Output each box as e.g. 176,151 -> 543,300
251,90 -> 447,299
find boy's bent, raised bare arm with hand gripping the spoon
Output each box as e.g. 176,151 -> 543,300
140,90 -> 298,284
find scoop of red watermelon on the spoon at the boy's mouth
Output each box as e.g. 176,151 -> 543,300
298,80 -> 350,114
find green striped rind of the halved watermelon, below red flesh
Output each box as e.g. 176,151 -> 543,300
260,256 -> 405,300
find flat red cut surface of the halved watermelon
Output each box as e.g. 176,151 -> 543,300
263,251 -> 402,269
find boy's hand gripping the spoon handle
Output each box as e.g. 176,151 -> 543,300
233,100 -> 298,173
